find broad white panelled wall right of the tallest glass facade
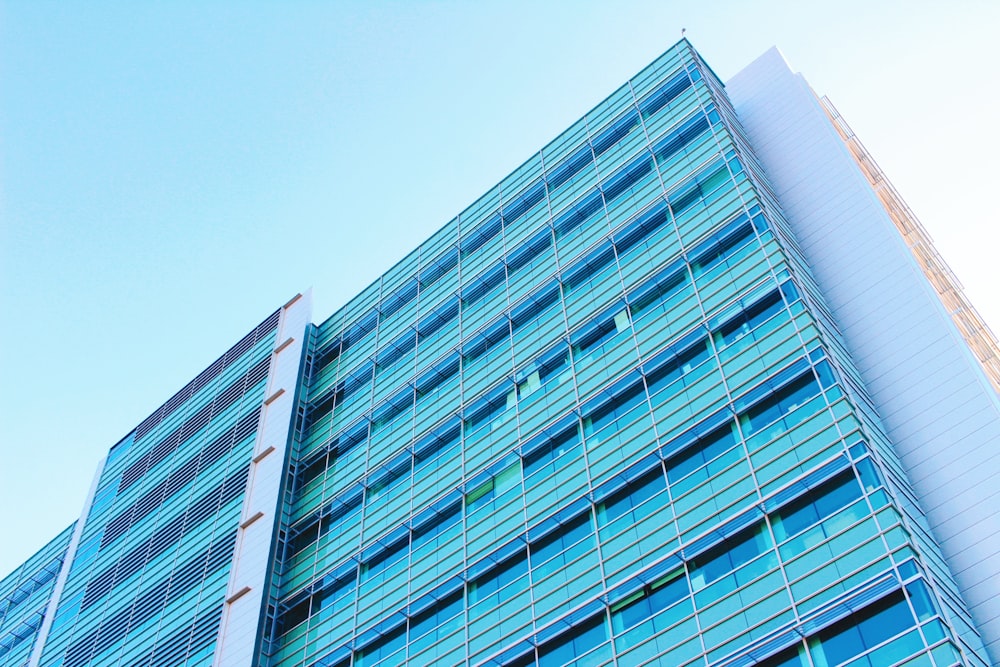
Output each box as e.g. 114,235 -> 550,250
727,49 -> 1000,663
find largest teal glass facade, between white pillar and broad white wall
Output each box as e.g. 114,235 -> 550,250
262,42 -> 985,666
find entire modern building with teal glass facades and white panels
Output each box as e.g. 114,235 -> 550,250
0,40 -> 1000,667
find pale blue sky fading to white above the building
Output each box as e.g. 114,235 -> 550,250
0,0 -> 1000,576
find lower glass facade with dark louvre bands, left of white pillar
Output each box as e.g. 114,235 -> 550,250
39,312 -> 278,667
